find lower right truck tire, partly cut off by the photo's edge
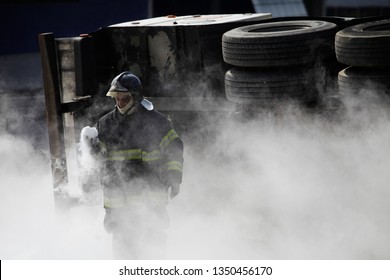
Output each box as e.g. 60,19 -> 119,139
337,66 -> 390,94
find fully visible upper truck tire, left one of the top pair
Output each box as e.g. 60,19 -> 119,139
222,20 -> 338,67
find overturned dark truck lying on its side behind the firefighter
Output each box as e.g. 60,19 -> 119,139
39,13 -> 390,206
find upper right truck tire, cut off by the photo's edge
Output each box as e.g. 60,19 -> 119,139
335,19 -> 390,67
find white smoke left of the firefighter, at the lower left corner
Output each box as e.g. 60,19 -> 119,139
0,132 -> 112,259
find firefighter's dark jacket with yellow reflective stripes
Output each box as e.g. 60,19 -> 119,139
96,106 -> 183,208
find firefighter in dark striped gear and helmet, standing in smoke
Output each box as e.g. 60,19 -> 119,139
92,72 -> 183,259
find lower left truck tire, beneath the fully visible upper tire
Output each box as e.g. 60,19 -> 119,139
225,68 -> 315,105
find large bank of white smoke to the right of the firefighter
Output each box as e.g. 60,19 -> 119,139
166,93 -> 390,259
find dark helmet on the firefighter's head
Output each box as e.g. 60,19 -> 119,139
106,71 -> 143,101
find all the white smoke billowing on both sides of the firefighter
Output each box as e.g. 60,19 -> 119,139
0,85 -> 390,259
